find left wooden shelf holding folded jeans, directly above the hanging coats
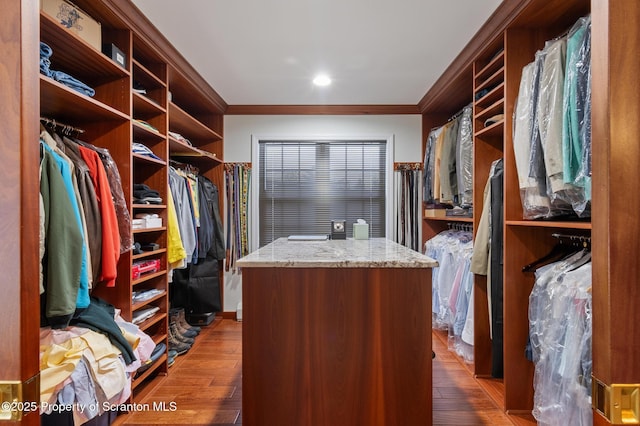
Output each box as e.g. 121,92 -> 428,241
40,75 -> 129,123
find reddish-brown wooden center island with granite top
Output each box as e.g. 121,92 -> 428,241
238,238 -> 437,426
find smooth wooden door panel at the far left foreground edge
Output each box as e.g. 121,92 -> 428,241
0,0 -> 40,425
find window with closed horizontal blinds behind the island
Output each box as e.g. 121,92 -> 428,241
258,140 -> 387,247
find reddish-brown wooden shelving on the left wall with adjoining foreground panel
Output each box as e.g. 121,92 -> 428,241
0,0 -> 226,414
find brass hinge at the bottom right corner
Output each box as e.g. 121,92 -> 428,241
591,376 -> 640,425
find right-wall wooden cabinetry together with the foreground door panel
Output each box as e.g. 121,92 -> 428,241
420,0 -> 640,424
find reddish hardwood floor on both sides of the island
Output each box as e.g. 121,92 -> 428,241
118,319 -> 535,426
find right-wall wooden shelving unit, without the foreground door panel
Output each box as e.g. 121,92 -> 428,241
420,0 -> 595,424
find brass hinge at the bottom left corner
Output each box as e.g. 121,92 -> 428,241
0,373 -> 40,422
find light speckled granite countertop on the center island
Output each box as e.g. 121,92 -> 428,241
237,238 -> 438,268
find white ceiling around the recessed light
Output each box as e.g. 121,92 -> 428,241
133,0 -> 501,105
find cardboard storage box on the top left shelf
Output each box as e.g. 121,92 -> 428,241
40,0 -> 102,50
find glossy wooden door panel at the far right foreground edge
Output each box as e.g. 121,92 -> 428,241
592,0 -> 640,390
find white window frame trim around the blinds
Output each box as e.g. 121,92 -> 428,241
249,135 -> 394,251
